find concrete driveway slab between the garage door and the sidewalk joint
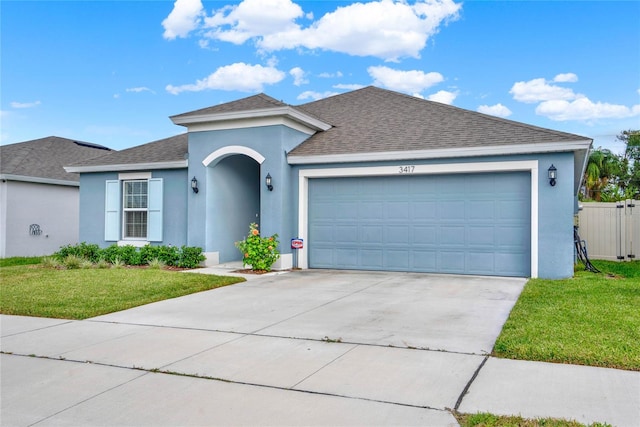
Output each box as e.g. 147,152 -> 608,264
93,270 -> 526,354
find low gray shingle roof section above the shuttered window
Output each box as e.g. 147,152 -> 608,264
65,133 -> 188,172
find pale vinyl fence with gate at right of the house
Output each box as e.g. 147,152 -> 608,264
578,200 -> 640,261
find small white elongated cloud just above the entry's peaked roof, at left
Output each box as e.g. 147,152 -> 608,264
166,62 -> 286,95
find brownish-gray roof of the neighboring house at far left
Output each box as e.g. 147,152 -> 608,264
0,136 -> 111,185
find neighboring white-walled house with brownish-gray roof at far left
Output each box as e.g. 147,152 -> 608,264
0,136 -> 111,258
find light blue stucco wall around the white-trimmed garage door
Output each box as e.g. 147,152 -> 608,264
292,152 -> 576,279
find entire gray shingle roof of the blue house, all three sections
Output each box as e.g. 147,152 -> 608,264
65,86 -> 590,171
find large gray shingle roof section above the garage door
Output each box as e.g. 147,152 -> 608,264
289,86 -> 588,156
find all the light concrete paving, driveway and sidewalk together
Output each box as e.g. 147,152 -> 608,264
0,267 -> 640,427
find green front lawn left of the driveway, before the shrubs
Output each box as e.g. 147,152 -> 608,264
0,264 -> 244,319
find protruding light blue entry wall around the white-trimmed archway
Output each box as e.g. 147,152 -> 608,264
188,125 -> 309,262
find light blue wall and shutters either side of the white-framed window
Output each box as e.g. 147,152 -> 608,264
79,169 -> 191,247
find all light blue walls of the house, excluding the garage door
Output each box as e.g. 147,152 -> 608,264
80,125 -> 576,279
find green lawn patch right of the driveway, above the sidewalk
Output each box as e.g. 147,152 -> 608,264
493,261 -> 640,371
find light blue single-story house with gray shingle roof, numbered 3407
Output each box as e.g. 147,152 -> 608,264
66,87 -> 592,278
